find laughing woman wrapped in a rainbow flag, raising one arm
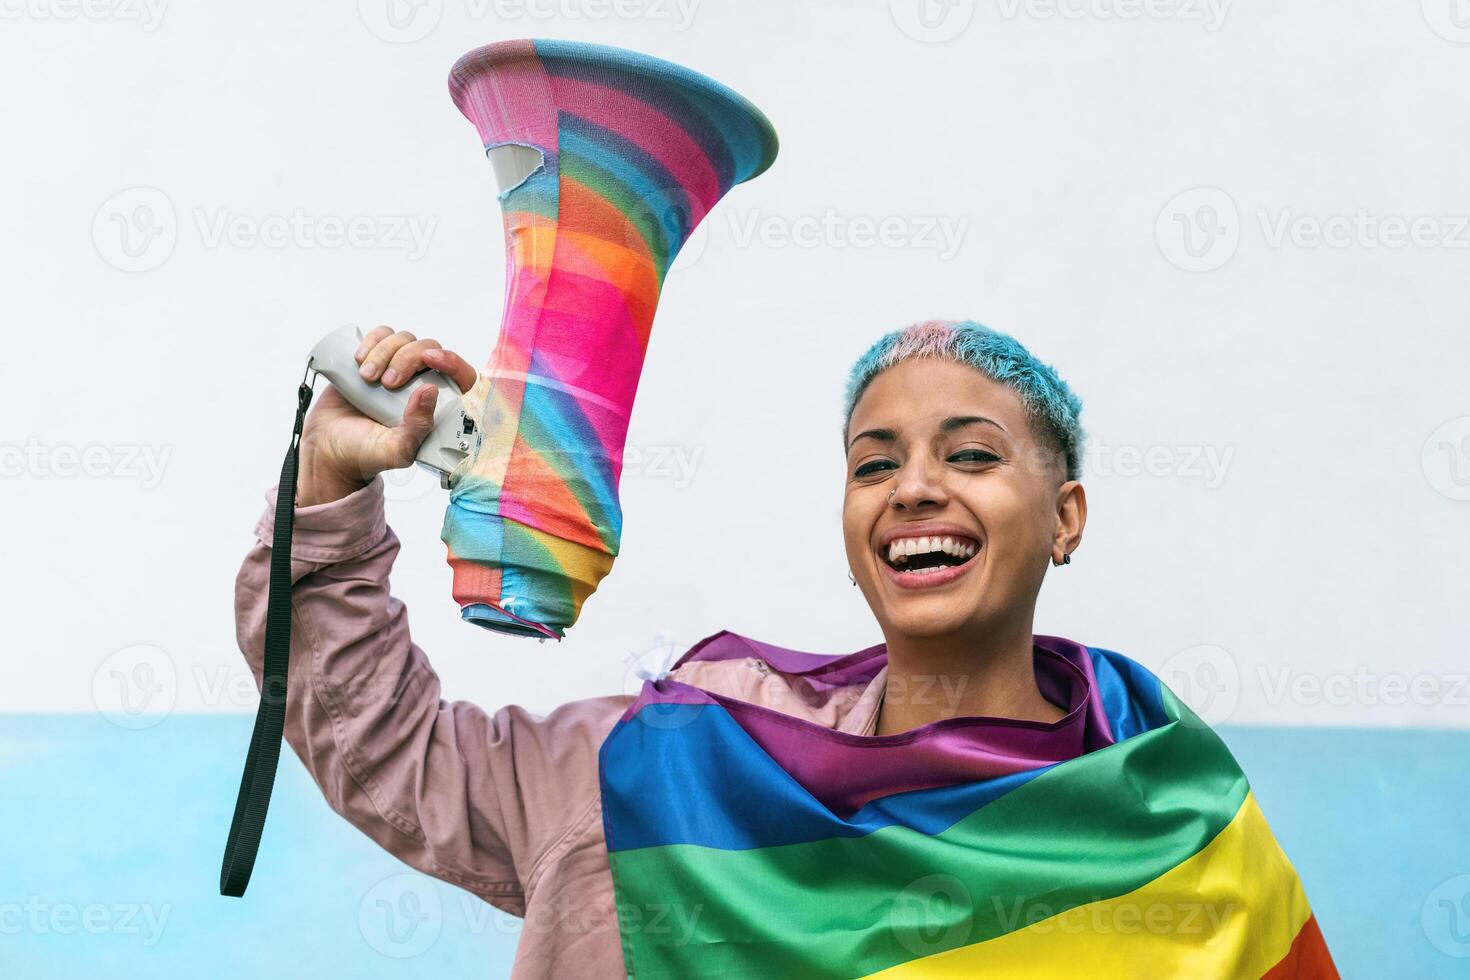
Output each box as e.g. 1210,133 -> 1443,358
237,322 -> 1336,977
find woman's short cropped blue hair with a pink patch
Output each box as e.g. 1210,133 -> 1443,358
842,320 -> 1086,480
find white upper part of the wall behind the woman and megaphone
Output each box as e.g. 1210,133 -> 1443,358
0,0 -> 1470,726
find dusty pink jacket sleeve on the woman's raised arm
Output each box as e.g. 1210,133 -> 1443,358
235,478 -> 629,915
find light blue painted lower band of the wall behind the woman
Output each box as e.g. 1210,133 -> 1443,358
0,716 -> 1470,980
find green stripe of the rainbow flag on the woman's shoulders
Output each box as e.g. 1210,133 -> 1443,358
610,688 -> 1248,980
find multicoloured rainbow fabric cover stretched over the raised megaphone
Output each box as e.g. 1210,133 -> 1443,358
441,40 -> 776,638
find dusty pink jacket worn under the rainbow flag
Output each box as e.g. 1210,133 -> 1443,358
235,479 -> 886,980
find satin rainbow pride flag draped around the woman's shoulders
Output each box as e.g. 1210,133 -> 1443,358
600,632 -> 1338,980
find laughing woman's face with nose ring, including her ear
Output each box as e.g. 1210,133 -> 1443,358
842,357 -> 1086,636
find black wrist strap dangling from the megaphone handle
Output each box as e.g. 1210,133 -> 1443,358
219,381 -> 312,898
